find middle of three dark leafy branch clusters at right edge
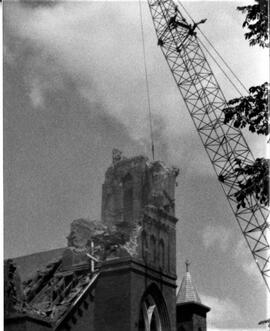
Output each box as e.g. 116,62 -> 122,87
224,83 -> 269,135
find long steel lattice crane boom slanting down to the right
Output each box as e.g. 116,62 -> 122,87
148,0 -> 270,291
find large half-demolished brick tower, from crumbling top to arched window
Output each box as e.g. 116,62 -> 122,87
95,150 -> 178,331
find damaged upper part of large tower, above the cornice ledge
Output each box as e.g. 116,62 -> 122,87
101,149 -> 179,273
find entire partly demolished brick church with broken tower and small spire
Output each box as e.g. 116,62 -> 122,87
4,150 -> 210,331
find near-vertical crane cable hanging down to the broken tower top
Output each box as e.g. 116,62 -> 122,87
139,0 -> 155,161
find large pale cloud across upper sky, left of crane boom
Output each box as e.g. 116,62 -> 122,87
2,2 -> 196,154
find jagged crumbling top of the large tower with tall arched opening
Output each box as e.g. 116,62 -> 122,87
101,149 -> 179,225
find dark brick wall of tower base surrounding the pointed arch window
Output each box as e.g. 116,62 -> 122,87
95,259 -> 176,331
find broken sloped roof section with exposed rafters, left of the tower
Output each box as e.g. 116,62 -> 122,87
5,253 -> 98,327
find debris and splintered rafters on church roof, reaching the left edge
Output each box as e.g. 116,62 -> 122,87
5,253 -> 98,325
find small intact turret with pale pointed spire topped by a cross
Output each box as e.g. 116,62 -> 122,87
176,261 -> 210,331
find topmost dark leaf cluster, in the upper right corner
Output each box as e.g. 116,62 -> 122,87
237,0 -> 269,47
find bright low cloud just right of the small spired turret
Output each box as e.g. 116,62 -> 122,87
201,295 -> 241,330
